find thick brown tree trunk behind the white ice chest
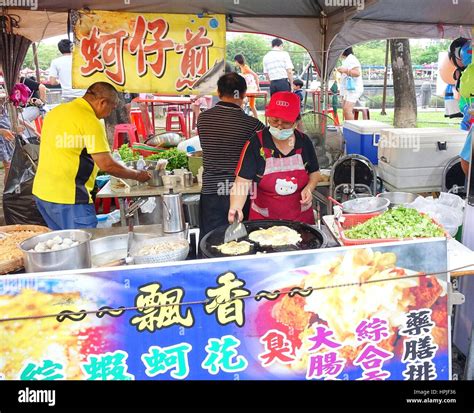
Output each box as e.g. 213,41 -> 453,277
390,39 -> 417,128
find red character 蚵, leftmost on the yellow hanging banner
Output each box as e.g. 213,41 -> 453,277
81,27 -> 127,86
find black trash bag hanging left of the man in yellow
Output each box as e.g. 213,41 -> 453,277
3,136 -> 46,226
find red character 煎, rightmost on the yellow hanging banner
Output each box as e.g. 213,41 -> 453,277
175,27 -> 213,91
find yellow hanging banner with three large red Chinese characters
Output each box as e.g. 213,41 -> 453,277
72,11 -> 225,95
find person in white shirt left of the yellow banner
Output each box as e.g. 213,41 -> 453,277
49,39 -> 85,103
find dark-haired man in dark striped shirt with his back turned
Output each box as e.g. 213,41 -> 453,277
197,72 -> 265,238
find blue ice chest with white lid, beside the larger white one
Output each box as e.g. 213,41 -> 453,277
342,120 -> 393,165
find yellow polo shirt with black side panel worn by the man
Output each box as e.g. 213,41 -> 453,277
33,98 -> 110,204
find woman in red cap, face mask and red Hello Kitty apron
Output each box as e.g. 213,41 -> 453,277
228,92 -> 320,224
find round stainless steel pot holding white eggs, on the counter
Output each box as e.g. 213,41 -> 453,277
20,229 -> 92,272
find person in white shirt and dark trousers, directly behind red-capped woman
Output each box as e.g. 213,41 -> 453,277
263,39 -> 293,96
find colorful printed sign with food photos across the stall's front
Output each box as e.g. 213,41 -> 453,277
0,240 -> 450,380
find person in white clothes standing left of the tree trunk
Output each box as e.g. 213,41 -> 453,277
336,47 -> 364,120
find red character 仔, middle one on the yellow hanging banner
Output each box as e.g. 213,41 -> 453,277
128,16 -> 174,78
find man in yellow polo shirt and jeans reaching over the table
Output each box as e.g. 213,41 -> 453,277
33,82 -> 150,230
